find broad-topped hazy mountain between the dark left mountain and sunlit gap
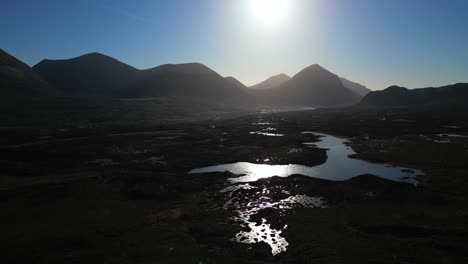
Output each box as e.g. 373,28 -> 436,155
124,63 -> 252,103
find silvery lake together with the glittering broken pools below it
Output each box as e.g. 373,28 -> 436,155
189,131 -> 423,255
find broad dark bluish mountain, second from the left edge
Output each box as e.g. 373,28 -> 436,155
33,53 -> 138,96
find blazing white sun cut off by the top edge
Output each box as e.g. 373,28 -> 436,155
249,0 -> 291,25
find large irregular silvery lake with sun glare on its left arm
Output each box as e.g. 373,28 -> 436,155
189,132 -> 423,185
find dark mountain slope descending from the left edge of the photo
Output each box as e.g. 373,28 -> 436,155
0,49 -> 57,99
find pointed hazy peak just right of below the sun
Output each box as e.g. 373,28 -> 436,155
257,64 -> 362,107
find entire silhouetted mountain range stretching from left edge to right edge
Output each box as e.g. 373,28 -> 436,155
7,50 -> 468,107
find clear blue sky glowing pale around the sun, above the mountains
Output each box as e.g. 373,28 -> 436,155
0,0 -> 468,89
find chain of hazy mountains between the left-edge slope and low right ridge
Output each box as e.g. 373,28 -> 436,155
28,53 -> 370,107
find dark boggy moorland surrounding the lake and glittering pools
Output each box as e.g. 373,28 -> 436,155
0,110 -> 468,263
